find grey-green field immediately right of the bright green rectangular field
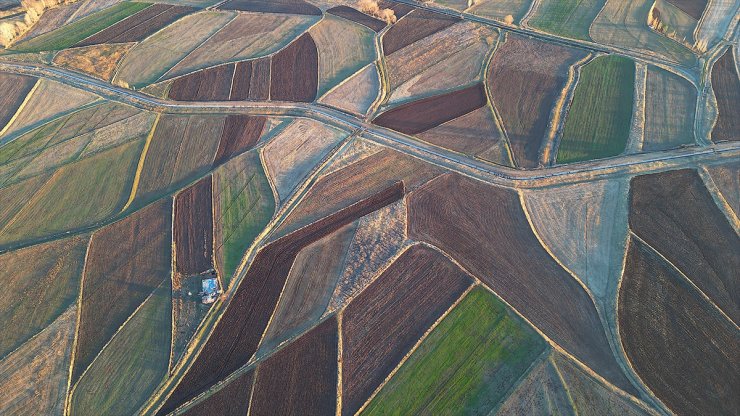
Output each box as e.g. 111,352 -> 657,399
642,66 -> 697,151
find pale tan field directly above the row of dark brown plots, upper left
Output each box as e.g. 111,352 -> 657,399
165,13 -> 317,78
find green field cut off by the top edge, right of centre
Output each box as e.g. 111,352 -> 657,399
528,0 -> 604,41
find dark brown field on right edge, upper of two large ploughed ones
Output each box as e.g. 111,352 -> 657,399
629,170 -> 740,322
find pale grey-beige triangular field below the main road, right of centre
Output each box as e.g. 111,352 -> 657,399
524,179 -> 629,298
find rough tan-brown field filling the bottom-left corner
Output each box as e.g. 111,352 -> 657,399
0,306 -> 77,415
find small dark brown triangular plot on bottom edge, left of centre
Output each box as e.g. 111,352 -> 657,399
182,371 -> 254,416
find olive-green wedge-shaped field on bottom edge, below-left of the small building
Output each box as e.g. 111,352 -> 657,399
70,279 -> 172,415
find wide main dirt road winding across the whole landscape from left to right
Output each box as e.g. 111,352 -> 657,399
0,62 -> 740,195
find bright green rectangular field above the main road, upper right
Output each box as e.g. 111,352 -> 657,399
557,55 -> 635,163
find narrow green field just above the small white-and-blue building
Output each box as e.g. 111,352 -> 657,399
217,151 -> 275,286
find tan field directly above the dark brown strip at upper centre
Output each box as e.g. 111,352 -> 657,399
386,23 -> 497,104
